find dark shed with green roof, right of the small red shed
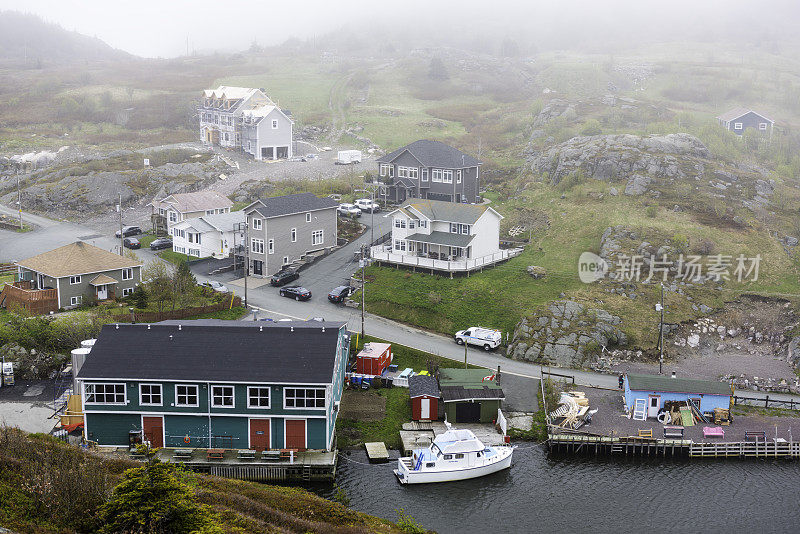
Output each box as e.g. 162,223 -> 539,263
439,369 -> 505,423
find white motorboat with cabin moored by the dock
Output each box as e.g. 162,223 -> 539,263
394,428 -> 514,484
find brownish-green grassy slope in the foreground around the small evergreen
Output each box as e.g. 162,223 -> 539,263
0,428 -> 412,534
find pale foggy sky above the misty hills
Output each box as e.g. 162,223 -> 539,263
0,0 -> 800,57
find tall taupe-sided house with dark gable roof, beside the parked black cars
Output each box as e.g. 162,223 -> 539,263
244,193 -> 338,276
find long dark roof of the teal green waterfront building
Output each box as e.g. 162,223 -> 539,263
78,319 -> 345,384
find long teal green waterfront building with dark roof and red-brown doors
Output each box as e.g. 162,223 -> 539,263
77,319 -> 349,451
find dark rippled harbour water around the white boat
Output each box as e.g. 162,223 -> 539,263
322,444 -> 800,534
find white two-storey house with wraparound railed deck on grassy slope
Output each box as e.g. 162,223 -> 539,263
371,199 -> 521,273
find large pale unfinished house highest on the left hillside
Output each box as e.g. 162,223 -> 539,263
198,85 -> 294,160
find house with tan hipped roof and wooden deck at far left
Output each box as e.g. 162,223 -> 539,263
14,241 -> 142,309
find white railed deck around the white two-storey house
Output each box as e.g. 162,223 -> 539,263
370,245 -> 523,273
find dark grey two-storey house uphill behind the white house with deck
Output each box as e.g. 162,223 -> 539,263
377,139 -> 482,204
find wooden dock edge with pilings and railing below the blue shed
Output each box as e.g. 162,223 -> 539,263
547,433 -> 800,459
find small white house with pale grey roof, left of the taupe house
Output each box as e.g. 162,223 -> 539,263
170,211 -> 246,258
